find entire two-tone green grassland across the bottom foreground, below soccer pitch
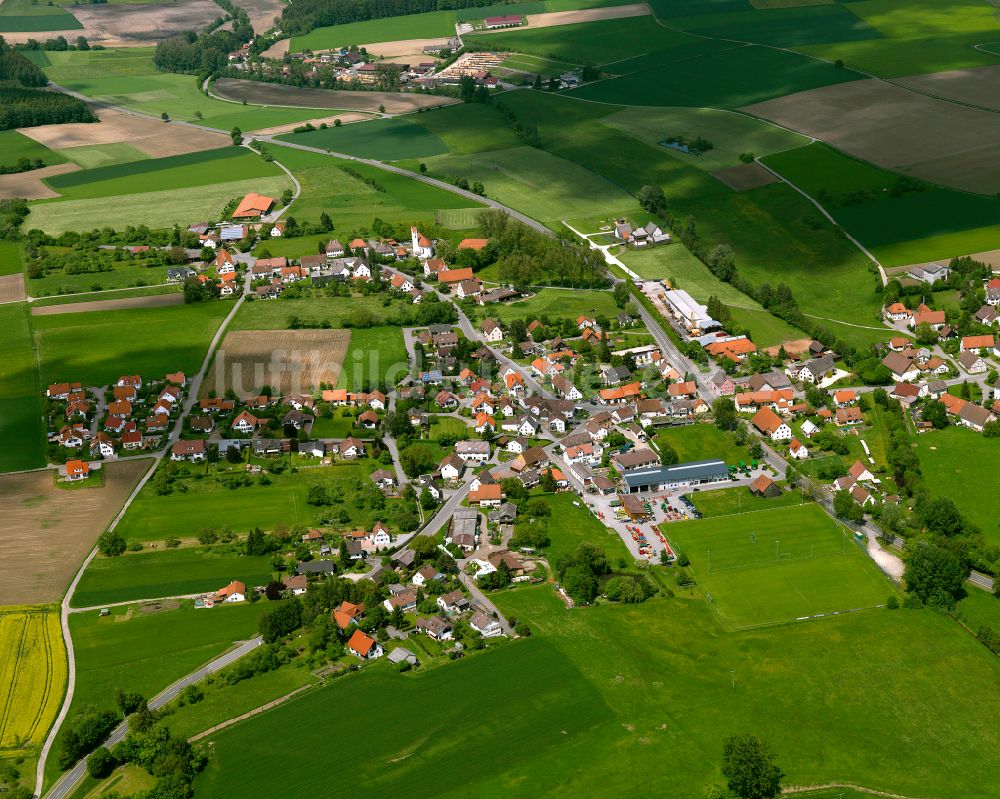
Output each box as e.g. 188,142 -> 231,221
196,584 -> 1000,799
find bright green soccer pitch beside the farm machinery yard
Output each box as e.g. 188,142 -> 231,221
662,505 -> 892,629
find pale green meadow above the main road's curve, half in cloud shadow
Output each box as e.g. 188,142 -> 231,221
425,147 -> 635,229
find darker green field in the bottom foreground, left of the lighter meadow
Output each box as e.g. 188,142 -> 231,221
196,640 -> 611,799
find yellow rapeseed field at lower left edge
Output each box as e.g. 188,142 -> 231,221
0,607 -> 66,756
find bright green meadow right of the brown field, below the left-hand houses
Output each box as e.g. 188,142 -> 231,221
118,461 -> 385,541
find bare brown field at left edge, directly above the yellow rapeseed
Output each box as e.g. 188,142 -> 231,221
0,460 -> 152,605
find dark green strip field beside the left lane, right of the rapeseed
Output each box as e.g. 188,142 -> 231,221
73,548 -> 272,608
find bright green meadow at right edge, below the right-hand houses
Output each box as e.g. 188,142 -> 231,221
917,426 -> 1000,545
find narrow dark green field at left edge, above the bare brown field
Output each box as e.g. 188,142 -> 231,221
0,302 -> 45,472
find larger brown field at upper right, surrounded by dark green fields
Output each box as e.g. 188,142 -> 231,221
742,80 -> 1000,194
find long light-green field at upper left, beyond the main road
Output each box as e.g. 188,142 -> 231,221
34,47 -> 316,133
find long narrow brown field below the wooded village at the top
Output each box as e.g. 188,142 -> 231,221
212,78 -> 458,114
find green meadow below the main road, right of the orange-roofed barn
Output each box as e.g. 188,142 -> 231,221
268,147 -> 469,230
